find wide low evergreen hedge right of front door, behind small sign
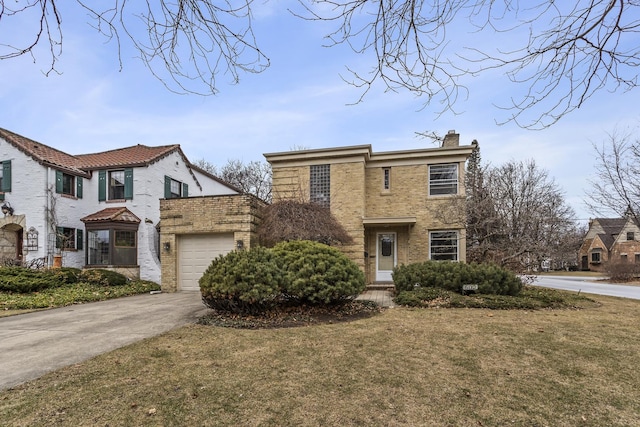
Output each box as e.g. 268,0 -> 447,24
393,261 -> 522,295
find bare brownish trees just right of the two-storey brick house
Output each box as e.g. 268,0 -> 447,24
467,156 -> 580,271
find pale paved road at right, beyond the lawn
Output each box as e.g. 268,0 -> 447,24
534,275 -> 640,299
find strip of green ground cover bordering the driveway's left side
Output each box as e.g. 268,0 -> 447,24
0,280 -> 160,316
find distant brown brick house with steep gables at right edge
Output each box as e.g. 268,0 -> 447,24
578,218 -> 640,271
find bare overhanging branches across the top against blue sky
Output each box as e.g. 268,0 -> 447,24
0,0 -> 640,128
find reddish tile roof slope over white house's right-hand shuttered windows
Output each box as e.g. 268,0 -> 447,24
75,144 -> 181,169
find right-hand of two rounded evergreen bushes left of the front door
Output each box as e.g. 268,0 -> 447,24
273,240 -> 365,304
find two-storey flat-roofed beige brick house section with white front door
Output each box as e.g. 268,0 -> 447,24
264,131 -> 475,283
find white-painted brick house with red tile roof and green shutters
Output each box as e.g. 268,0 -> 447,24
0,129 -> 238,283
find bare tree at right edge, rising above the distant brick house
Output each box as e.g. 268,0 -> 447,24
585,131 -> 640,224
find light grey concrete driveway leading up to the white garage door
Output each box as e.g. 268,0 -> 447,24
0,292 -> 208,390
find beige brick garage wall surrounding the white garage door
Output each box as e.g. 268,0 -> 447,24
160,194 -> 265,292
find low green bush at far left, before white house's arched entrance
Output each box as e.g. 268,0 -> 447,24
0,267 -> 67,293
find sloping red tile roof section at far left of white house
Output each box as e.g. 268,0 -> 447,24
0,128 -> 89,177
